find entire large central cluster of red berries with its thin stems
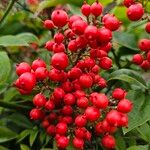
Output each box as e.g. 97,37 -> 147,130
15,1 -> 132,149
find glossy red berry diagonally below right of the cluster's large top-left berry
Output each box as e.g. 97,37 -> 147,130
72,20 -> 87,35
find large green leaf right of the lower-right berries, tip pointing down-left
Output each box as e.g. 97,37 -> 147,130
123,90 -> 150,134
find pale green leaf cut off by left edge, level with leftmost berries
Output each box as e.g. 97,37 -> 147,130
0,52 -> 11,83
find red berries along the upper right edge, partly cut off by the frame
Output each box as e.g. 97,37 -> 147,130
124,0 -> 150,70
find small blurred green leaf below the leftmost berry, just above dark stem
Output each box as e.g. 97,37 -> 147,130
4,88 -> 19,101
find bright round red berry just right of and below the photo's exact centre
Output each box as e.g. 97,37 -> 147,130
79,74 -> 93,88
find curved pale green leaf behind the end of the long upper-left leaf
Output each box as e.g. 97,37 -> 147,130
17,33 -> 39,43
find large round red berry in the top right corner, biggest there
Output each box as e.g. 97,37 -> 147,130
127,3 -> 144,21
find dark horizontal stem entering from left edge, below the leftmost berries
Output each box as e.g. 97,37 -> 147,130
0,100 -> 30,110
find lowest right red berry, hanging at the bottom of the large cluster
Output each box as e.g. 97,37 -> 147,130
101,135 -> 116,149
